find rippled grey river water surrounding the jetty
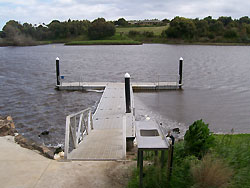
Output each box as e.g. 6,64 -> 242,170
0,44 -> 250,145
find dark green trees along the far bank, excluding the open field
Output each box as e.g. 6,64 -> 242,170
0,16 -> 250,45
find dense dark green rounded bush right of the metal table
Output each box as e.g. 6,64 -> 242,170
184,119 -> 214,158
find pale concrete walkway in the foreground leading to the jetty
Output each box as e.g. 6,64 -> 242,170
0,136 -> 134,188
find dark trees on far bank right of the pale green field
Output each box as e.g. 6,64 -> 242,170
162,16 -> 250,42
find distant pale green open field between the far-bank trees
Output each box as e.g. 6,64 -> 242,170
116,26 -> 168,35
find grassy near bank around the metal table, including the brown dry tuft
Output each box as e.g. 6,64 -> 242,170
128,134 -> 250,188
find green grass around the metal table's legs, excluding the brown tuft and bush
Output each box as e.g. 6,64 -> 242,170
127,134 -> 250,188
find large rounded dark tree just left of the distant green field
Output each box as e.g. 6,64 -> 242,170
88,18 -> 115,39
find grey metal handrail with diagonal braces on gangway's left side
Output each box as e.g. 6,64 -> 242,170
64,108 -> 93,159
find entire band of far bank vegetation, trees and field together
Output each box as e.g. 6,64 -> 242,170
0,16 -> 250,46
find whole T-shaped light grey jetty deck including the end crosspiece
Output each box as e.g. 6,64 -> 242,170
63,82 -> 182,160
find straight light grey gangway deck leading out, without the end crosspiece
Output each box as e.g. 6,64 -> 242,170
68,83 -> 129,160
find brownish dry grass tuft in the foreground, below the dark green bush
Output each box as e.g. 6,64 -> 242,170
191,155 -> 232,188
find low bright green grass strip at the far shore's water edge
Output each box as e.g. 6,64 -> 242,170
65,40 -> 142,45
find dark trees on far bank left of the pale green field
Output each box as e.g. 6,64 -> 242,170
0,18 -> 115,45
